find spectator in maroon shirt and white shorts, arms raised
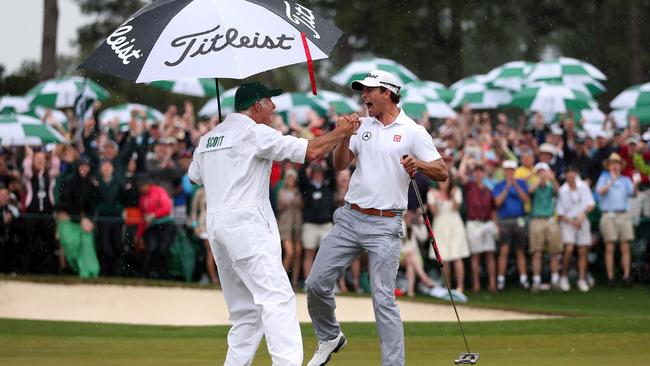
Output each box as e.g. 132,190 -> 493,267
459,157 -> 498,292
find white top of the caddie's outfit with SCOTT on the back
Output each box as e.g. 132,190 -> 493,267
188,113 -> 308,213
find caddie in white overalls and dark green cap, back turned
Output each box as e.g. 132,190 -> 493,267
188,82 -> 359,366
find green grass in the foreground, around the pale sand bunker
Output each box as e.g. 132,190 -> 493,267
0,278 -> 650,366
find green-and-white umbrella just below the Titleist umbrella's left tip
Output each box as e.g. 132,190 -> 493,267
25,76 -> 108,108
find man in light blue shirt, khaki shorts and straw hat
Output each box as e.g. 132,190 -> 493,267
596,153 -> 636,287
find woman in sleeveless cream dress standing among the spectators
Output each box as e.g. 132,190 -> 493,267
427,173 -> 469,292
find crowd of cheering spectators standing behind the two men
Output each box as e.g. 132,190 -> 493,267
0,102 -> 650,296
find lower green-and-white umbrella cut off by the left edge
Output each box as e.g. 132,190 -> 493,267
0,114 -> 65,146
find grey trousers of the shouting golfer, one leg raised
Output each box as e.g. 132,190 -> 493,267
306,206 -> 404,366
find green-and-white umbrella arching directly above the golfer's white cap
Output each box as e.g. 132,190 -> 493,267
332,57 -> 419,87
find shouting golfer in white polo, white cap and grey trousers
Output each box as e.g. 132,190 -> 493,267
306,70 -> 448,366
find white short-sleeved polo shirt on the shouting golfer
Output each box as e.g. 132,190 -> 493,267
345,110 -> 440,210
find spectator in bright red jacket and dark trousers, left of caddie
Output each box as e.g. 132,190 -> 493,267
138,176 -> 176,279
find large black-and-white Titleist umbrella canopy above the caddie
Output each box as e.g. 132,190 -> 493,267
80,0 -> 343,82
